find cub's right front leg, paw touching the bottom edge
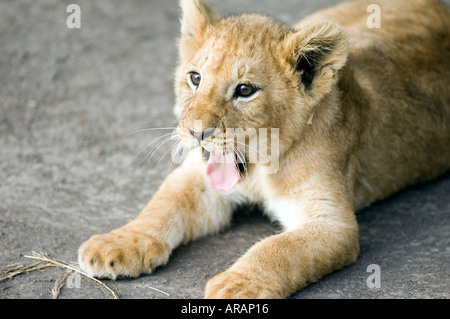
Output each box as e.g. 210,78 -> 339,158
205,186 -> 359,299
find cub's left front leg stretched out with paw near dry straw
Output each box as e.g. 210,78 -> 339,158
78,153 -> 233,279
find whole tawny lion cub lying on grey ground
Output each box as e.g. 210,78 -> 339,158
79,0 -> 450,298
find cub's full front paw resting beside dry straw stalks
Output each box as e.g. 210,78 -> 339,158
78,232 -> 170,279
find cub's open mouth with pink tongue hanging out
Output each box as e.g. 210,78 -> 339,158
203,149 -> 247,192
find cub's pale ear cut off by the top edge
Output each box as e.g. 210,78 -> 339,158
179,0 -> 222,59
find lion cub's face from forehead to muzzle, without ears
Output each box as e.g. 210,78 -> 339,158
177,16 -> 289,160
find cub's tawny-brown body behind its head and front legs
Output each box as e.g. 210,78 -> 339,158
297,0 -> 450,208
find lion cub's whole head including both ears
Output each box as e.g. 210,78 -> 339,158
175,0 -> 347,190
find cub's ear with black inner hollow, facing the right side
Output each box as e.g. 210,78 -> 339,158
284,21 -> 348,94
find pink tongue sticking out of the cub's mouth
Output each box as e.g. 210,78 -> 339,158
206,152 -> 241,192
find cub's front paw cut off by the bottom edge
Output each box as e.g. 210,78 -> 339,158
205,270 -> 280,299
